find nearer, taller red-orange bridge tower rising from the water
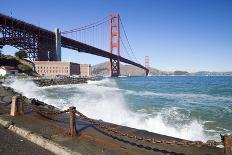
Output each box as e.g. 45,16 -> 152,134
110,14 -> 120,77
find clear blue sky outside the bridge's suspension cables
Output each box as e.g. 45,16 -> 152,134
0,0 -> 232,72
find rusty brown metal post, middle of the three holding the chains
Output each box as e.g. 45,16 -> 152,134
69,106 -> 77,137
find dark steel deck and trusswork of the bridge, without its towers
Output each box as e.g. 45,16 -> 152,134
0,14 -> 149,76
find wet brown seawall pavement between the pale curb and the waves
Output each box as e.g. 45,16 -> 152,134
0,85 -> 223,154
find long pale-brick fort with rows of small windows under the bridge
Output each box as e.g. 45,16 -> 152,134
33,61 -> 90,76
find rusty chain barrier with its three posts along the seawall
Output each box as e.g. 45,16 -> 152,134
7,95 -> 232,154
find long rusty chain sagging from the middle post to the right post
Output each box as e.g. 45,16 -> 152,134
76,110 -> 224,147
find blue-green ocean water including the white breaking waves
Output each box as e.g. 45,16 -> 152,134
5,76 -> 232,141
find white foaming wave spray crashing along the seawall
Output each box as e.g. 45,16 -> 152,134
5,79 -> 212,140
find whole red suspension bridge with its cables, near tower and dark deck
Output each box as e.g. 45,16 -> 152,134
0,14 -> 149,77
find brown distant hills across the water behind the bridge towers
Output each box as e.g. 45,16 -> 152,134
91,62 -> 189,76
